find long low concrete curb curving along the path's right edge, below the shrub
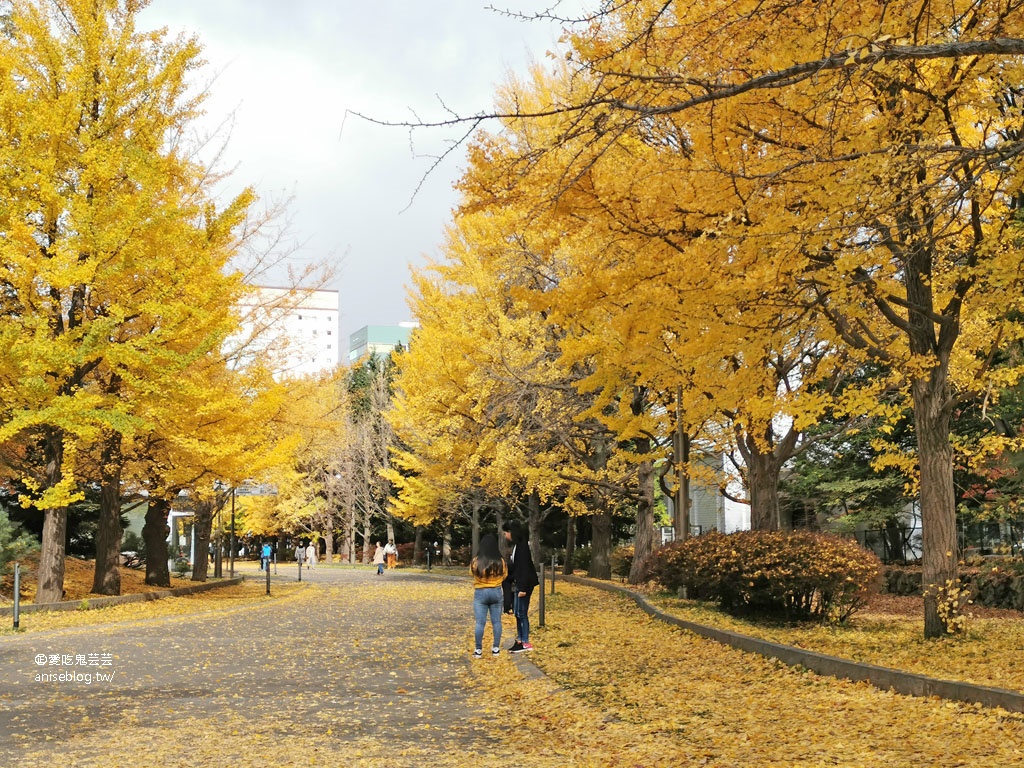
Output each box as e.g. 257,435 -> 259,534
561,575 -> 1024,712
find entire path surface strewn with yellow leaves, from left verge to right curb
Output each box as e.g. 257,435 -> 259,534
0,568 -> 1024,768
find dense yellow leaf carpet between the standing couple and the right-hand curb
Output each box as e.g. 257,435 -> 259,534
488,584 -> 1024,767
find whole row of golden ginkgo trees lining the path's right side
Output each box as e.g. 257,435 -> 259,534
378,0 -> 1024,637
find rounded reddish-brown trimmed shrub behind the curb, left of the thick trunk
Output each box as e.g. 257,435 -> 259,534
644,530 -> 882,622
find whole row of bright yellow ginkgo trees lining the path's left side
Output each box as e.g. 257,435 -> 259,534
0,0 -> 395,602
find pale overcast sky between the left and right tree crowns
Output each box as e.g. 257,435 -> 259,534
140,0 -> 584,354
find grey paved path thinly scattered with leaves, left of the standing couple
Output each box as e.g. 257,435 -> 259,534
0,566 -> 499,766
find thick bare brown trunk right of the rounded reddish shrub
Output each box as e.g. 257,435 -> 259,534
911,368 -> 957,638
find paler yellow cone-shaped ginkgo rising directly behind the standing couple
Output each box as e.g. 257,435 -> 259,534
390,189 -> 653,568
